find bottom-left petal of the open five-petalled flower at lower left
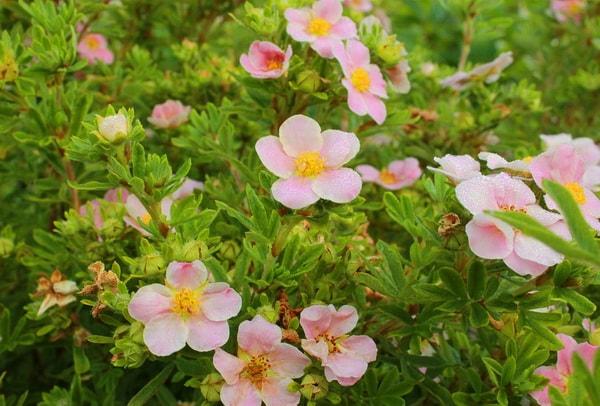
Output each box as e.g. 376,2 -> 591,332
144,313 -> 188,357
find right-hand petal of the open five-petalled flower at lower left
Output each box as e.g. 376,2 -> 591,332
201,282 -> 242,321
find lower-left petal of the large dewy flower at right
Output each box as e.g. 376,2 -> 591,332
466,215 -> 514,259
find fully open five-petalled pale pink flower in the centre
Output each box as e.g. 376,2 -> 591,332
255,115 -> 362,209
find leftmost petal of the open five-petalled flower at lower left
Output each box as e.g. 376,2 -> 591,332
127,283 -> 171,324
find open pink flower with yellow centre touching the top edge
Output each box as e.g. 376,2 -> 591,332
285,0 -> 356,58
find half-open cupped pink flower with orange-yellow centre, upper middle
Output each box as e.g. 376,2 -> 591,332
240,41 -> 292,79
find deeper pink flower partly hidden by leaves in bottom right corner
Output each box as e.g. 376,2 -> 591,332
531,334 -> 599,406
